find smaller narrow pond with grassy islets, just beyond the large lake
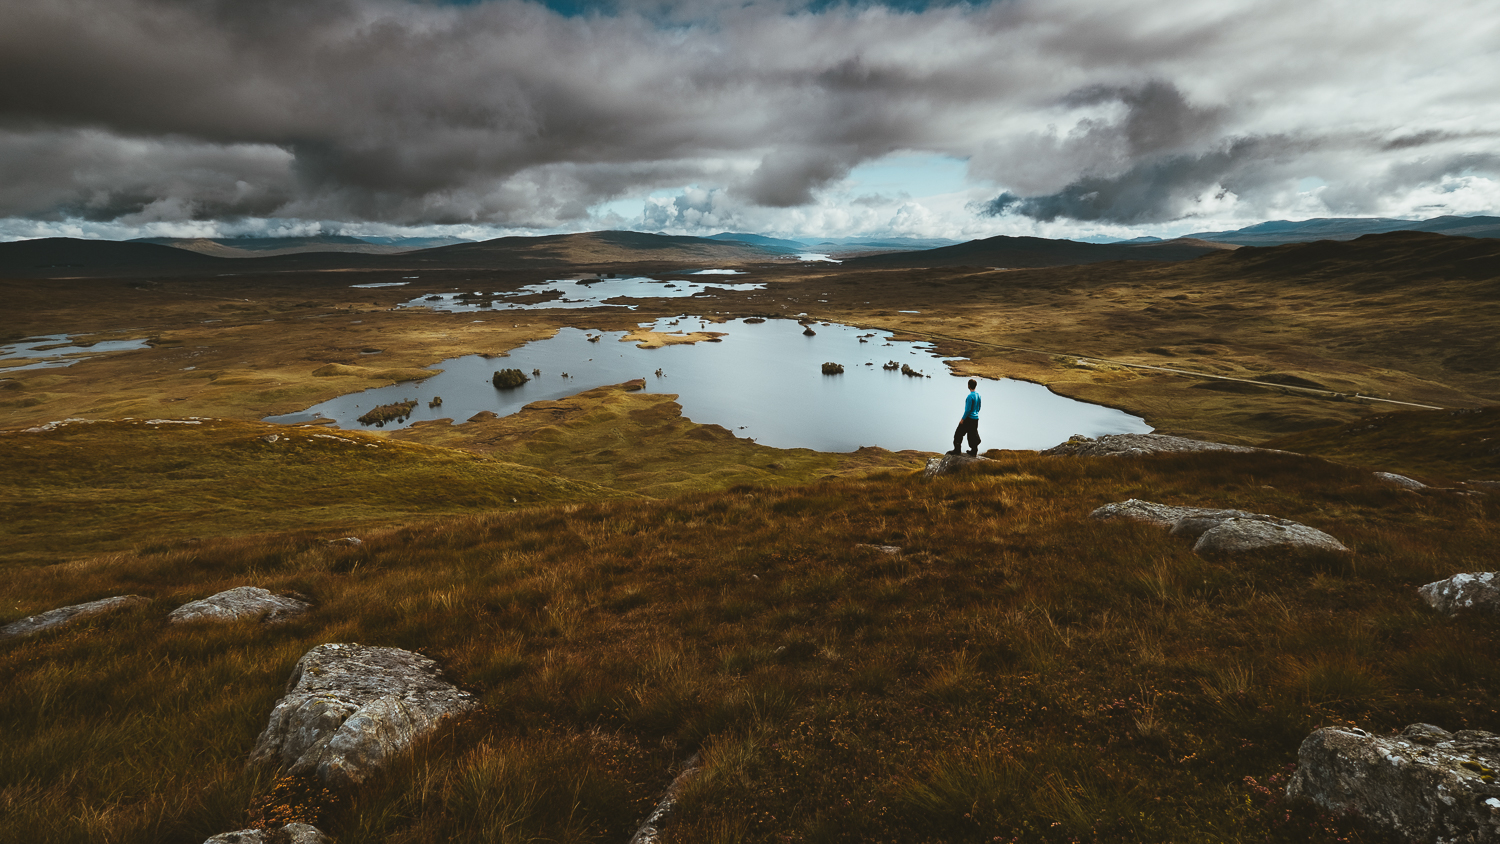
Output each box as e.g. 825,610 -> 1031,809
402,270 -> 765,313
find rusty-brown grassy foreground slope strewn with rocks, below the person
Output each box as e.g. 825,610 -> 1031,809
0,454 -> 1500,844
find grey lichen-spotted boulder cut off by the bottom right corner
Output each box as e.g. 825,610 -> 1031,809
1287,724 -> 1500,844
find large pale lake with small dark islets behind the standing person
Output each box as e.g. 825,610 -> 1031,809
267,316 -> 1152,451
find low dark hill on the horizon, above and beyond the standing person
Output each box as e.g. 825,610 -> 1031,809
843,235 -> 1233,270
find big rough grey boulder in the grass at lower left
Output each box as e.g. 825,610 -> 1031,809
251,645 -> 474,787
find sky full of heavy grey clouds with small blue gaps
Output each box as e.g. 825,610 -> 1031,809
0,0 -> 1500,240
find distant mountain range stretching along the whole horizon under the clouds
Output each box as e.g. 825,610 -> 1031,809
11,217 -> 1500,277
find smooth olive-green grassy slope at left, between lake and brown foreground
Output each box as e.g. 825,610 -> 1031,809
0,420 -> 632,565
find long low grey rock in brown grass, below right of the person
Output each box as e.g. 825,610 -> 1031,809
1089,498 -> 1349,556
